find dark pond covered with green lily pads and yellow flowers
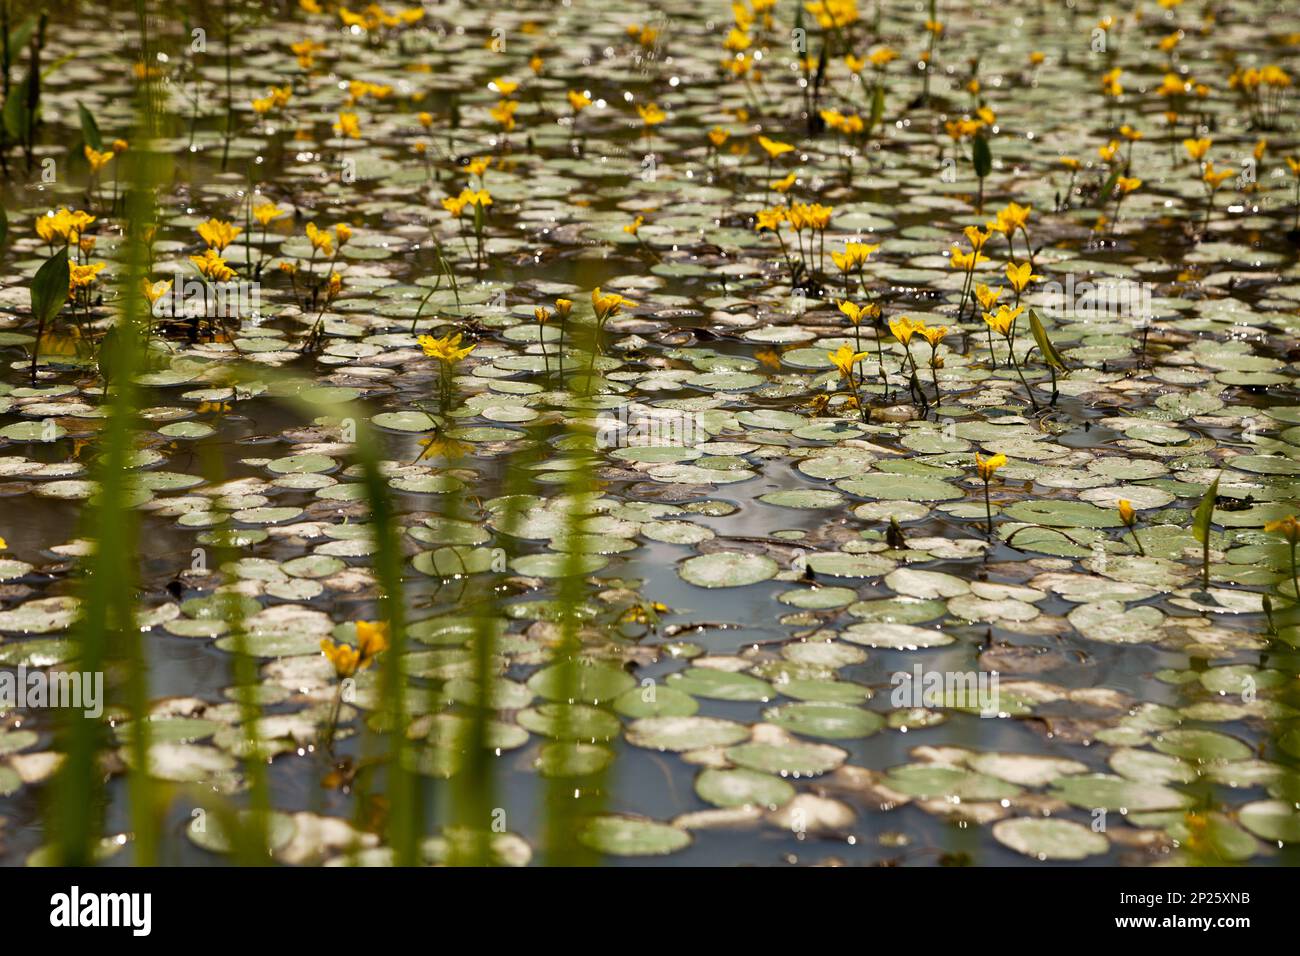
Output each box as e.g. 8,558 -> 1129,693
0,0 -> 1300,866
